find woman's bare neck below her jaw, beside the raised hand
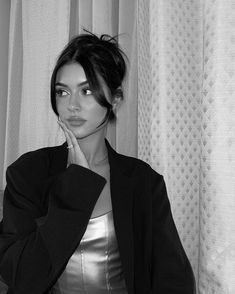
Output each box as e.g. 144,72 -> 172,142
77,128 -> 108,166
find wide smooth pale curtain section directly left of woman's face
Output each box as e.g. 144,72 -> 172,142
19,0 -> 70,154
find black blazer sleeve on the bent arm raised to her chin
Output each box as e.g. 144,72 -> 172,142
0,154 -> 106,294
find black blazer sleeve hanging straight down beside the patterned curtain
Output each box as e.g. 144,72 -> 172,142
151,170 -> 196,294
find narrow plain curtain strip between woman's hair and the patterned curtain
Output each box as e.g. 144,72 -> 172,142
116,0 -> 138,157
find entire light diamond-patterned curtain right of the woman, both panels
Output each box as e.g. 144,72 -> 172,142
138,0 -> 235,294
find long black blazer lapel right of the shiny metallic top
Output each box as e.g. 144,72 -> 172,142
105,140 -> 134,293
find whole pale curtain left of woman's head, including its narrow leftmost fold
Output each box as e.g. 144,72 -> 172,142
3,0 -> 70,187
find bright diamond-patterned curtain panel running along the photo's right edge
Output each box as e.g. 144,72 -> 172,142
199,0 -> 235,294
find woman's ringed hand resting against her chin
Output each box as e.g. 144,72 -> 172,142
58,120 -> 90,169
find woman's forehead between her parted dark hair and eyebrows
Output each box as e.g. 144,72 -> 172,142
56,63 -> 87,84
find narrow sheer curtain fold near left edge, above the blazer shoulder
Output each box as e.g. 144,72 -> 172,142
2,0 -> 23,188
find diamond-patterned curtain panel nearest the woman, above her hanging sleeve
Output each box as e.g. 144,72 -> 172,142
138,0 -> 202,288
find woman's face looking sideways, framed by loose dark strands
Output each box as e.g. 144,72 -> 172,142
55,63 -> 110,139
